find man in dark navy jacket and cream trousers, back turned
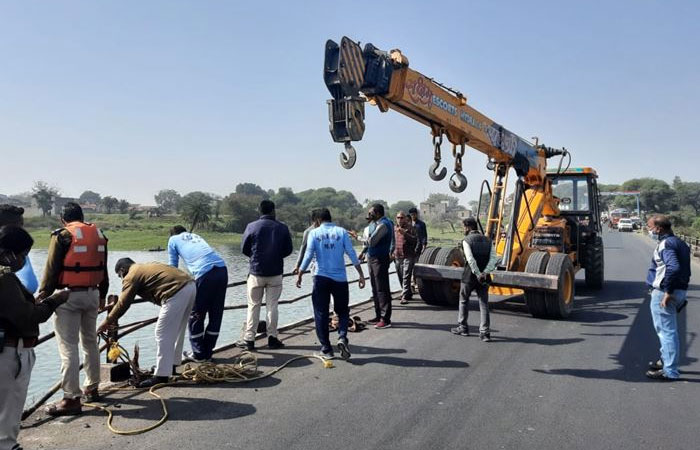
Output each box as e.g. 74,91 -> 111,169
236,200 -> 293,350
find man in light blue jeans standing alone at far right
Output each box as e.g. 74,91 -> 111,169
646,215 -> 690,381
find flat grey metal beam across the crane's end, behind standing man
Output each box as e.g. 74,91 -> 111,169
413,264 -> 559,291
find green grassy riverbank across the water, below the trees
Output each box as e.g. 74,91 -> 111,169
25,214 -> 462,251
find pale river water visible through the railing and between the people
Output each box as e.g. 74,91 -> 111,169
25,246 -> 399,406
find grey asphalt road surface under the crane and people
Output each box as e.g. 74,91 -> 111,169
20,232 -> 700,450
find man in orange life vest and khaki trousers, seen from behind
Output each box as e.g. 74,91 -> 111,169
37,202 -> 109,416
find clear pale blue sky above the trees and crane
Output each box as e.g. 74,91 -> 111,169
0,0 -> 700,204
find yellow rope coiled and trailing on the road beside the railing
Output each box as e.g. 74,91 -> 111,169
84,352 -> 335,436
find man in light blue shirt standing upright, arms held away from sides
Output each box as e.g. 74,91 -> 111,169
297,208 -> 365,359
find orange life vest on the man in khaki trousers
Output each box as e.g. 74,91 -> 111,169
58,222 -> 107,287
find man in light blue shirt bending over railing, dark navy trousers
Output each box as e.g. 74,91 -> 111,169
168,225 -> 228,362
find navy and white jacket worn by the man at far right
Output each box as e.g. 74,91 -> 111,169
647,233 -> 690,294
